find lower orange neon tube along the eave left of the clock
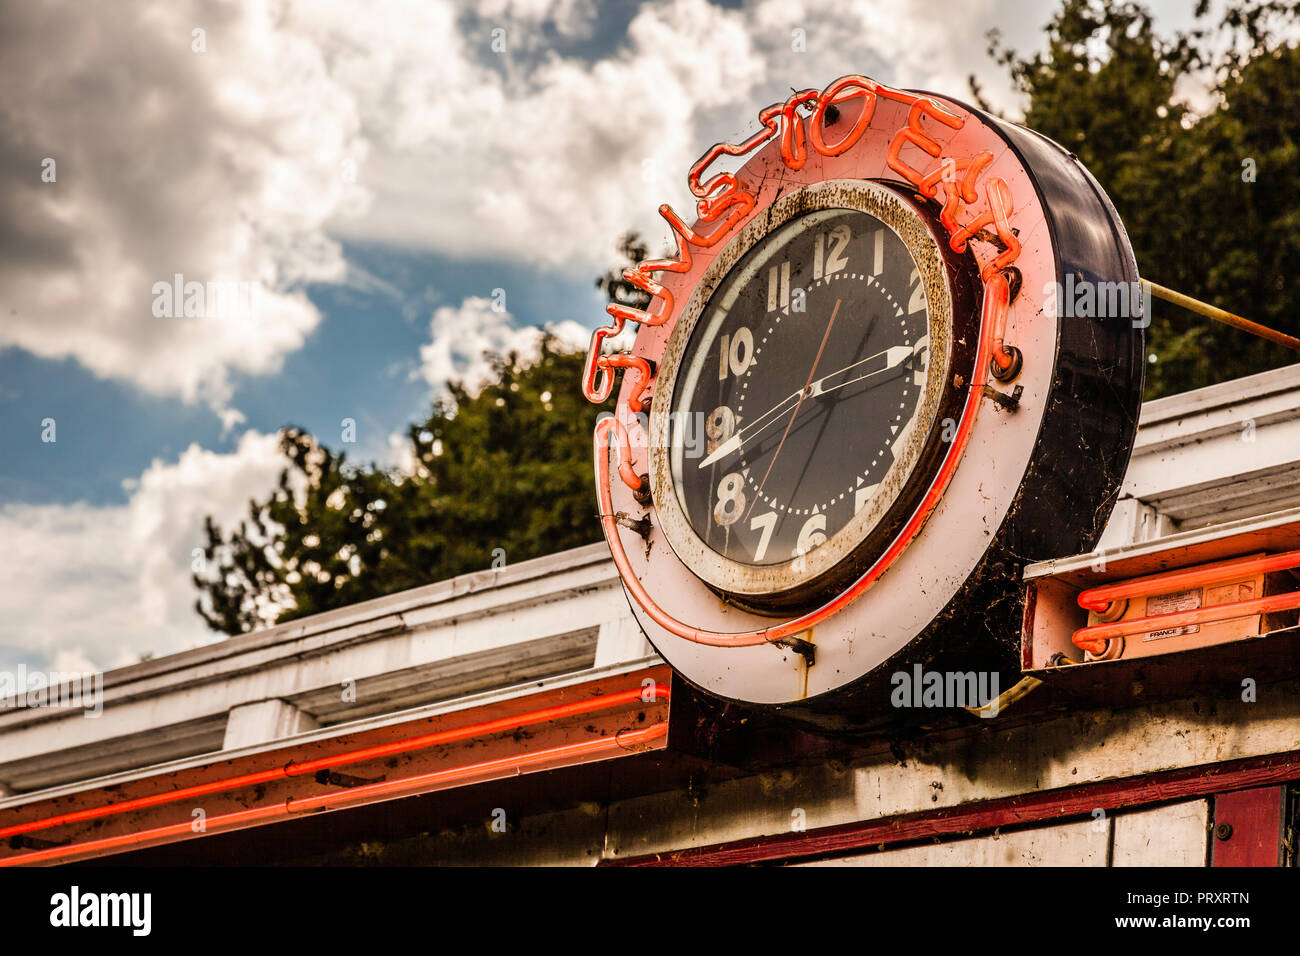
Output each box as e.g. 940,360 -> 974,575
0,722 -> 668,866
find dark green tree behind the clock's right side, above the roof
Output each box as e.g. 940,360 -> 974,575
971,0 -> 1300,398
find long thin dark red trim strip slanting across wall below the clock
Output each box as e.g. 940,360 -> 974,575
601,750 -> 1300,866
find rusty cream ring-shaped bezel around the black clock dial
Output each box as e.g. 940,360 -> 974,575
649,179 -> 983,614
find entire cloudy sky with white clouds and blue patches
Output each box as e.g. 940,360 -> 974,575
0,0 -> 1216,669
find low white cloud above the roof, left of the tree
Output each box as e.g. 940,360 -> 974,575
0,432 -> 286,670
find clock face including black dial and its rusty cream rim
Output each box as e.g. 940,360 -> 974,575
653,183 -> 977,608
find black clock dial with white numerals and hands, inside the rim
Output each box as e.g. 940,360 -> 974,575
670,208 -> 928,567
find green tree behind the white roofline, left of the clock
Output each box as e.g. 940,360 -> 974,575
194,338 -> 616,633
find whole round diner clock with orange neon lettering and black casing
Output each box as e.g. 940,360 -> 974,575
584,75 -> 1144,723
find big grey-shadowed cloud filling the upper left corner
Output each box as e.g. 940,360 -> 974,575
0,0 -> 364,408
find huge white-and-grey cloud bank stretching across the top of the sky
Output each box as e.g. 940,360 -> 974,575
0,0 -> 1066,413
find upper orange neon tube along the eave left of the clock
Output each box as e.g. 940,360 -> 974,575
0,684 -> 670,836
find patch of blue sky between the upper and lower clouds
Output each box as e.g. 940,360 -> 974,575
0,242 -> 605,505
